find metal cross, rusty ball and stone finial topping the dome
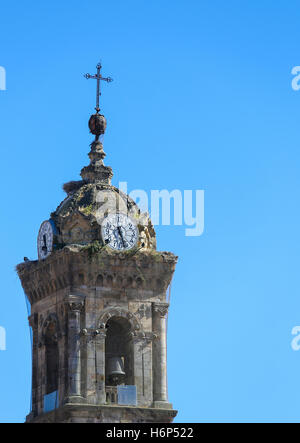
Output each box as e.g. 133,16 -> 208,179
81,63 -> 113,184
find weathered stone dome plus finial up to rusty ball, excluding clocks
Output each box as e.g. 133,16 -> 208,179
51,108 -> 156,250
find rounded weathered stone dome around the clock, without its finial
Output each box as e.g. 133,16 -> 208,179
51,180 -> 156,250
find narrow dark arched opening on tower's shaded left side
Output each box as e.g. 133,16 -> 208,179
45,319 -> 59,395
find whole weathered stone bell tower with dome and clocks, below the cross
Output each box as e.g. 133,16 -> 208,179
17,65 -> 177,423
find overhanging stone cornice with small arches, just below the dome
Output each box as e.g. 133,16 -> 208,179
17,246 -> 177,305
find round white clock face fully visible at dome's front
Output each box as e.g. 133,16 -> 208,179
102,213 -> 139,251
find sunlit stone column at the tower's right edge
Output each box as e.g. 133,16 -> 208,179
152,303 -> 172,409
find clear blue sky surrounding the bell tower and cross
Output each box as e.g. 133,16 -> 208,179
0,0 -> 300,422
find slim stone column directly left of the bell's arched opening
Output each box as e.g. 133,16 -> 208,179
95,328 -> 106,405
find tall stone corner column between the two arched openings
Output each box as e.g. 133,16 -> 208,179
67,295 -> 84,403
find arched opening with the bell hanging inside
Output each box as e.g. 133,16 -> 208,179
105,317 -> 133,386
